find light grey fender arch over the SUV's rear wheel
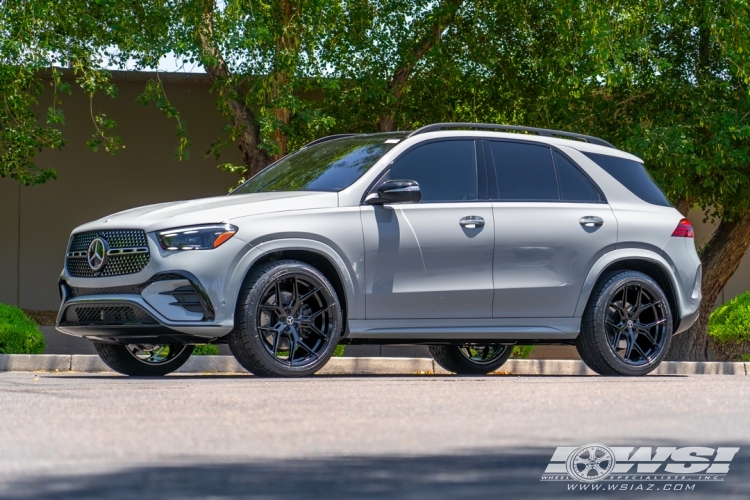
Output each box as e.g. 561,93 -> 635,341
576,249 -> 681,327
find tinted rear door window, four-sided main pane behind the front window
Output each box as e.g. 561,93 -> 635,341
490,142 -> 560,201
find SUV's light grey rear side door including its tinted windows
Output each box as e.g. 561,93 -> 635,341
484,141 -> 617,318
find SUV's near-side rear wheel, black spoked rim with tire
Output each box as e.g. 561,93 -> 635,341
576,271 -> 674,376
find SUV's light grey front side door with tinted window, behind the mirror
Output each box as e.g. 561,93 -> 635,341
361,140 -> 495,319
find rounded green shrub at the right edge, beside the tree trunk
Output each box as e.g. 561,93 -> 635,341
708,292 -> 750,361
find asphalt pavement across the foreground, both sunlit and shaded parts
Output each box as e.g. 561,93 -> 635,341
0,372 -> 750,500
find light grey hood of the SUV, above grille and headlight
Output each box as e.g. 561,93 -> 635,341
73,191 -> 338,233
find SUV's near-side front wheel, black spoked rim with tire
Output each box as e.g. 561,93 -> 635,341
228,260 -> 343,377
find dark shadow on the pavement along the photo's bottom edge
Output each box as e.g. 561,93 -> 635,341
0,450 -> 750,500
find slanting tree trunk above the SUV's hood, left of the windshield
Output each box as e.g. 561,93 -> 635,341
197,0 -> 273,178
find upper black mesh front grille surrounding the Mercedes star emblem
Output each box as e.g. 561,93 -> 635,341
65,229 -> 151,278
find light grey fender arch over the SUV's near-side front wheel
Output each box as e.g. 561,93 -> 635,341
229,239 -> 358,333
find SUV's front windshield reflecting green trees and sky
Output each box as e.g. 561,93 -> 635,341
232,133 -> 405,194
